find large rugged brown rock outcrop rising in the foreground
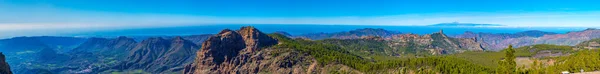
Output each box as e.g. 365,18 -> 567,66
184,27 -> 278,74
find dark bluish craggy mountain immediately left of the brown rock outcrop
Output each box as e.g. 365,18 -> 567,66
116,37 -> 199,73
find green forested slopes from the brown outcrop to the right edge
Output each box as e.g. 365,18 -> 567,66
270,34 -> 600,74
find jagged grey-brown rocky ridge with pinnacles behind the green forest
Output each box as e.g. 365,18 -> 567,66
388,31 -> 484,54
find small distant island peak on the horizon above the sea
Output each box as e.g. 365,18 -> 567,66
427,22 -> 504,27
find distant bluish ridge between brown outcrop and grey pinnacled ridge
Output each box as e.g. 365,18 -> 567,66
295,28 -> 401,40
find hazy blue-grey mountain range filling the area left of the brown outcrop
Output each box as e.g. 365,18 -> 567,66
0,35 -> 214,74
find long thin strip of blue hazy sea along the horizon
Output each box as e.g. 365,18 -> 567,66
61,24 -> 586,37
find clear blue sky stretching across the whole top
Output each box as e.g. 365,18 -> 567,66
0,0 -> 600,37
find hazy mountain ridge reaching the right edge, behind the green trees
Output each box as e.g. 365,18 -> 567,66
456,28 -> 600,50
